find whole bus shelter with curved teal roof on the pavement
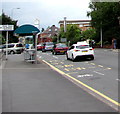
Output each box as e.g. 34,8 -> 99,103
14,24 -> 40,64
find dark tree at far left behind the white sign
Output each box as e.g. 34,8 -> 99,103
0,13 -> 18,43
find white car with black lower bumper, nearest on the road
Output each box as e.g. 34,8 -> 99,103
66,42 -> 94,61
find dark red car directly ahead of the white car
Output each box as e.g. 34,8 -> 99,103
52,43 -> 68,55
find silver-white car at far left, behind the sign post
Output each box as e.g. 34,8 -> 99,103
2,43 -> 24,54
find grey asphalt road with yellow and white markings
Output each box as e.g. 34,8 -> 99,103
38,49 -> 120,108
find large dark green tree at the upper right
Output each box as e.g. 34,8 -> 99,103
87,2 -> 120,43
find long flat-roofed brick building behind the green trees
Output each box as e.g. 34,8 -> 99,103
59,20 -> 92,31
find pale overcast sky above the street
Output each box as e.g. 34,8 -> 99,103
1,0 -> 90,29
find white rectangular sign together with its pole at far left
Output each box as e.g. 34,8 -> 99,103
0,25 -> 14,60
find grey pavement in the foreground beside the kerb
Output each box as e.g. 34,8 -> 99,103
0,54 -> 116,112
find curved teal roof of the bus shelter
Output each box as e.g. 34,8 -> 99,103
14,24 -> 40,36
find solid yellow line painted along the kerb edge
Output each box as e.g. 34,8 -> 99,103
42,60 -> 120,106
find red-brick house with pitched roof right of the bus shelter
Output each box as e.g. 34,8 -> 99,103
38,25 -> 60,43
